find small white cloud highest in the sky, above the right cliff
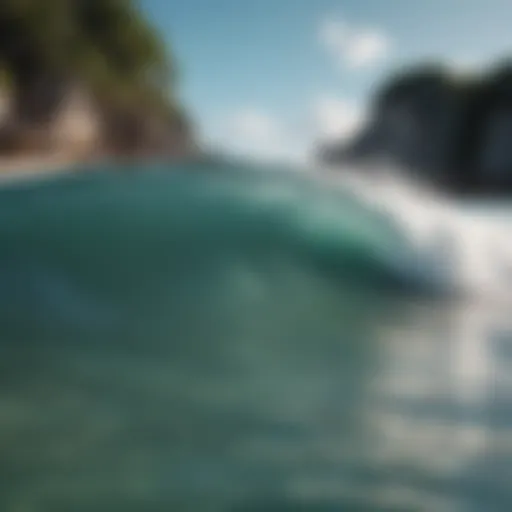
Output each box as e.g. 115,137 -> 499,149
320,19 -> 391,68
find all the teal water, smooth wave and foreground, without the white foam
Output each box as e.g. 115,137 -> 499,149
0,165 -> 512,512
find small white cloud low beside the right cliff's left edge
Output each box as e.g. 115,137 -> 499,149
314,95 -> 365,141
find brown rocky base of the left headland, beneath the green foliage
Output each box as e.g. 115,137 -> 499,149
0,81 -> 196,160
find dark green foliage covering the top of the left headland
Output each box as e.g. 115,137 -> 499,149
0,0 -> 174,114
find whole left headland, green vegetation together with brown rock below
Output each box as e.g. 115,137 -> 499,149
0,0 -> 191,162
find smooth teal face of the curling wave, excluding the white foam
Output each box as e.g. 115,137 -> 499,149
0,162 -> 429,334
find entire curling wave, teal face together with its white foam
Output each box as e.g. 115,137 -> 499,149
0,161 -> 512,340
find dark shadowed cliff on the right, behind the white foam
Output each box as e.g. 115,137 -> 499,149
321,62 -> 512,194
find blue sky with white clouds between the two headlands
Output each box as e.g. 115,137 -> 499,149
142,0 -> 512,159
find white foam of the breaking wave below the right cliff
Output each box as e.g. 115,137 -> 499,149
327,164 -> 512,300
